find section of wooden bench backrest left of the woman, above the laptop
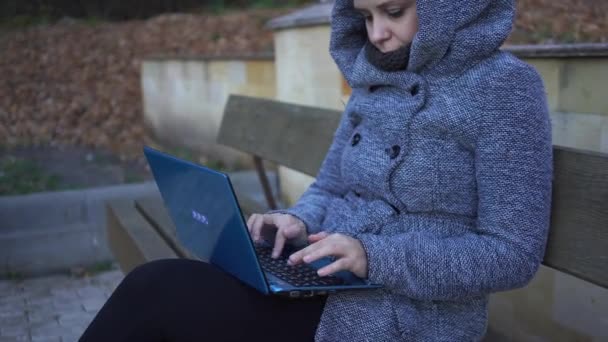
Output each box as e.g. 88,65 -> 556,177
217,95 -> 341,176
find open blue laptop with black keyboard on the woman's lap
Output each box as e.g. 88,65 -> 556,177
144,146 -> 381,298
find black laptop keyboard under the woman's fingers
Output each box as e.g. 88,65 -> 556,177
256,246 -> 344,286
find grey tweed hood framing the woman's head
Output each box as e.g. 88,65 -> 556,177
330,0 -> 515,87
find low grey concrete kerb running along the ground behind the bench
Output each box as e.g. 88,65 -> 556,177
0,171 -> 278,278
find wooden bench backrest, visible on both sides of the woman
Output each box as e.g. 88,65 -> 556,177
218,95 -> 608,287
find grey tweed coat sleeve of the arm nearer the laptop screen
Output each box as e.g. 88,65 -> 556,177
270,111 -> 353,234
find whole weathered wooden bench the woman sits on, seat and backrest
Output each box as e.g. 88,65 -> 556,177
107,95 -> 608,340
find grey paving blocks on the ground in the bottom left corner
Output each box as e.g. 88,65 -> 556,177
0,270 -> 123,342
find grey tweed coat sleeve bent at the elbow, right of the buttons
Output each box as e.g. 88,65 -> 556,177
357,66 -> 553,300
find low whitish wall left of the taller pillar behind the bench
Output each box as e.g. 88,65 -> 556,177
141,58 -> 276,167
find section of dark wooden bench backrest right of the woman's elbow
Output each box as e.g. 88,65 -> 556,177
544,147 -> 608,287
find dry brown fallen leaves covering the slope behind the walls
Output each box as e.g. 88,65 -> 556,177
0,0 -> 608,158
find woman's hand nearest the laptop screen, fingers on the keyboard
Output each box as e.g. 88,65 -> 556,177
247,213 -> 306,258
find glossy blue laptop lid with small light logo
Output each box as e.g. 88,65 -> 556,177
144,146 -> 270,294
